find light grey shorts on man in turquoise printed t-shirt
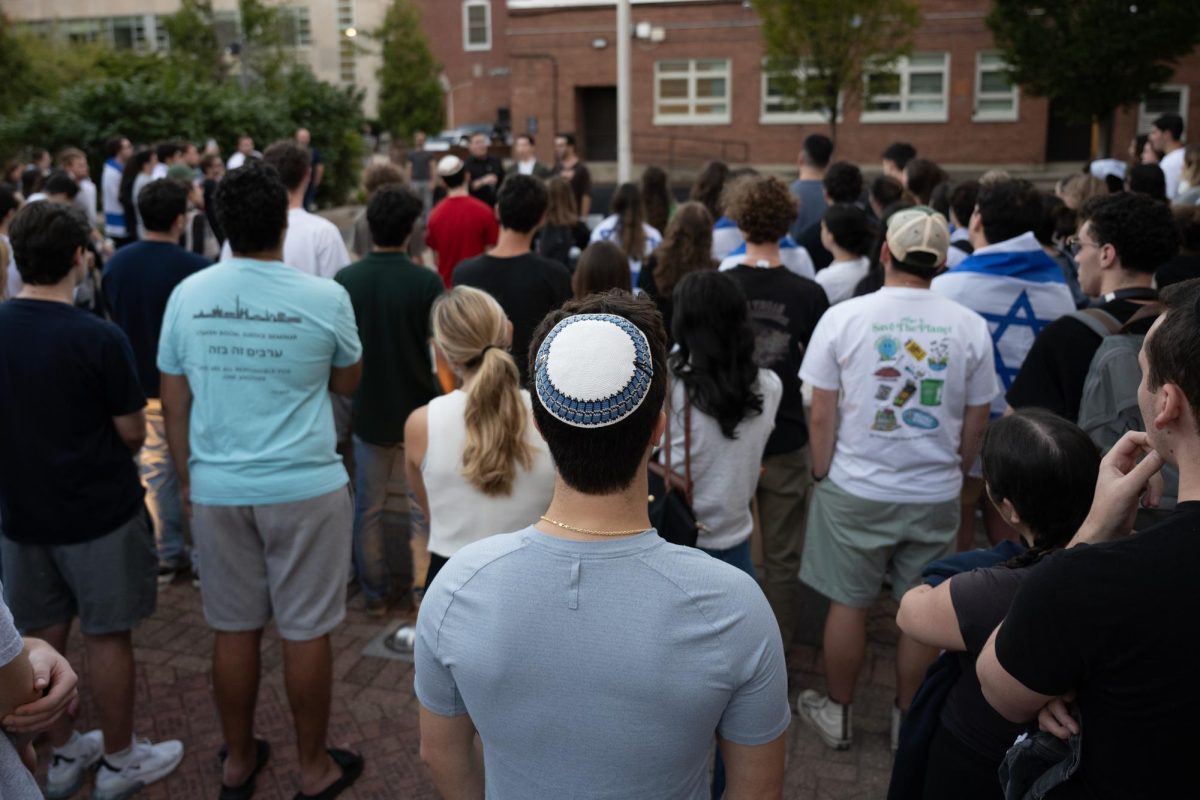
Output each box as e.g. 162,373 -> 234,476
192,487 -> 354,642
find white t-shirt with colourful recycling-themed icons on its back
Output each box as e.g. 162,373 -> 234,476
800,287 -> 1000,503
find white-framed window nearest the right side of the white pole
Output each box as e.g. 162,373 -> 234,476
654,59 -> 731,125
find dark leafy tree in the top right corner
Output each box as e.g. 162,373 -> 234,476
988,0 -> 1200,157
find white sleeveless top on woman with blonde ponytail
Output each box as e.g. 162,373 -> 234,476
421,390 -> 554,558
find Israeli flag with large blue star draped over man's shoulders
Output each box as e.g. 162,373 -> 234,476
934,233 -> 1075,414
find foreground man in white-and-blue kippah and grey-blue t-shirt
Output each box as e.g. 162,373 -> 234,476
414,291 -> 791,800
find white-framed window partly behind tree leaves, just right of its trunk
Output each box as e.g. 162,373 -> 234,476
859,53 -> 950,122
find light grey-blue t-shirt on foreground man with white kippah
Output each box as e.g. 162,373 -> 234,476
414,528 -> 792,800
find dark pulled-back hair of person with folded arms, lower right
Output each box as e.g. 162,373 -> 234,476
980,408 -> 1100,566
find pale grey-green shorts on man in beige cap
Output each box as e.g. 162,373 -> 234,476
800,479 -> 960,608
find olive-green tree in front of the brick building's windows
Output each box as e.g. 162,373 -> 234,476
754,0 -> 920,142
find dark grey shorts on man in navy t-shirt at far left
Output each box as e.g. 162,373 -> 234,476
0,510 -> 158,636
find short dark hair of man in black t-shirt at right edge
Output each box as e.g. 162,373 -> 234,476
1142,280 -> 1200,431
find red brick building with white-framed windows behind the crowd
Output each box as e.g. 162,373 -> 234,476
419,0 -> 1200,169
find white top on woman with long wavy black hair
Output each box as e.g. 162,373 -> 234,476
660,369 -> 784,551
